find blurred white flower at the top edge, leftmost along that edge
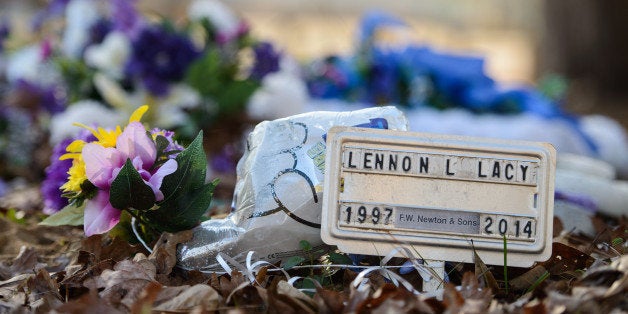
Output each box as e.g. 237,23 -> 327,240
61,0 -> 100,58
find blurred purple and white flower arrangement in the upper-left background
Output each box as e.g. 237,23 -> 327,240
0,0 -> 282,181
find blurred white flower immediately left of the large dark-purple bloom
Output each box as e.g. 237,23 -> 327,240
85,32 -> 131,79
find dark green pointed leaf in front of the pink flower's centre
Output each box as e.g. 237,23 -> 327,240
109,159 -> 155,210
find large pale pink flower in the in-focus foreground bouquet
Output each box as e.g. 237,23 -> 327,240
82,122 -> 177,236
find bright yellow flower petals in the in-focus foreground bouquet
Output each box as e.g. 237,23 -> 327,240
59,105 -> 148,193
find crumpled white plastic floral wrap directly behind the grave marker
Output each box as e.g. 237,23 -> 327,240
179,107 -> 408,271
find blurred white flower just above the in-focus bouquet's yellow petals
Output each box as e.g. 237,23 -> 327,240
50,100 -> 128,145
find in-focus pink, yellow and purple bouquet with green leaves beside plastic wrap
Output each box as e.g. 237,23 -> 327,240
42,106 -> 217,236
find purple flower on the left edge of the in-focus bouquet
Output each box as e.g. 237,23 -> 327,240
41,139 -> 72,215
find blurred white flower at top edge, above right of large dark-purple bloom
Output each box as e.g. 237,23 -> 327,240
188,0 -> 241,35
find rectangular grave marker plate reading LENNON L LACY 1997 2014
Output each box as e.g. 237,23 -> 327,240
321,127 -> 556,267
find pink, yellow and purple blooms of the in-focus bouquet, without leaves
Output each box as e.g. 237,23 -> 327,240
52,106 -> 183,236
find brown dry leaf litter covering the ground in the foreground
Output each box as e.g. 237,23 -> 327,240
0,190 -> 628,313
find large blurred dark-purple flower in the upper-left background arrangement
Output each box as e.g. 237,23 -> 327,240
126,27 -> 200,96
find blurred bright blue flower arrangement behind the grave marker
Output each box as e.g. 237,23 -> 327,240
306,12 -> 564,117
